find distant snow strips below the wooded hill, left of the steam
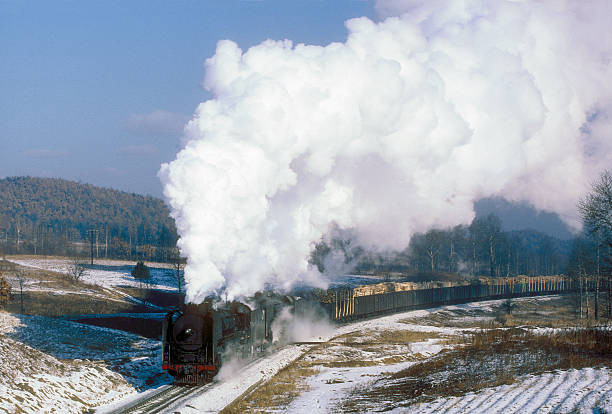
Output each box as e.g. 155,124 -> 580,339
9,258 -> 177,291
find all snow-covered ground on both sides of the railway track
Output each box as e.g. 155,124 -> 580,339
0,259 -> 612,414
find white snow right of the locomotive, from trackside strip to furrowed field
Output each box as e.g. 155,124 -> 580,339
169,298 -> 612,413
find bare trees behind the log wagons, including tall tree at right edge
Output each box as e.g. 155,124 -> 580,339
309,171 -> 612,308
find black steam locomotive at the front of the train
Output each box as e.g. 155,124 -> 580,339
162,297 -> 283,384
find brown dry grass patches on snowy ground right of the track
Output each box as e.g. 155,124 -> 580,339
224,296 -> 612,413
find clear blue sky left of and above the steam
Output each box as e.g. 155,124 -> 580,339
0,0 -> 374,196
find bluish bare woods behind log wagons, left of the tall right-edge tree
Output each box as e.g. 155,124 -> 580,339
310,214 -> 574,277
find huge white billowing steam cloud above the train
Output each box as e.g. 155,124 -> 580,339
160,0 -> 612,301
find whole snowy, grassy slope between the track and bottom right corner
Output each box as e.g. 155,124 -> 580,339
218,295 -> 612,413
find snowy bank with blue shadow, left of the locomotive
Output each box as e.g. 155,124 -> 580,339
0,312 -> 170,413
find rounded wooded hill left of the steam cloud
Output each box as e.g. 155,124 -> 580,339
0,177 -> 177,260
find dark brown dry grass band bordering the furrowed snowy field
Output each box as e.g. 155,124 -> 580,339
342,328 -> 612,412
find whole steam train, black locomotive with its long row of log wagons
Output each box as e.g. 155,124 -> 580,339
162,276 -> 574,384
